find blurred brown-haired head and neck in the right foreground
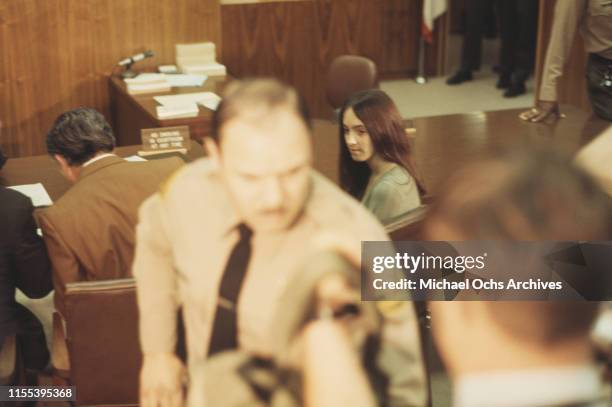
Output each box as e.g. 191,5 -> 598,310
425,152 -> 612,388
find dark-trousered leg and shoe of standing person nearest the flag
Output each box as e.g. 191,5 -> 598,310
446,0 -> 495,85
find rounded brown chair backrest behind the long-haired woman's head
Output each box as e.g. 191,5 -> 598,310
327,55 -> 378,109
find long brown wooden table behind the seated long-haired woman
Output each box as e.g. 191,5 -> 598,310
314,106 -> 610,196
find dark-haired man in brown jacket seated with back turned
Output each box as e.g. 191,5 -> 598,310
39,108 -> 182,311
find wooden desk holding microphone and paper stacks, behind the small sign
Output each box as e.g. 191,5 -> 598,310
109,76 -> 231,146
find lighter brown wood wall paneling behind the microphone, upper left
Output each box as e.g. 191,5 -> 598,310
0,0 -> 222,156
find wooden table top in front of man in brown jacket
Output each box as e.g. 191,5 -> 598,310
0,142 -> 204,202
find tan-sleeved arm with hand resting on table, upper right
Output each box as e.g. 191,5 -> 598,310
520,0 -> 588,123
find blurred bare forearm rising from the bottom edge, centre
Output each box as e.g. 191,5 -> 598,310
303,320 -> 376,407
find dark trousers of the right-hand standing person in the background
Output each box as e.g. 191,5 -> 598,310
496,0 -> 539,82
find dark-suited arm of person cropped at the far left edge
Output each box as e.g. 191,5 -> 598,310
13,198 -> 53,298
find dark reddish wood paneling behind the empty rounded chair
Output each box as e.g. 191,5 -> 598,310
221,0 -> 430,118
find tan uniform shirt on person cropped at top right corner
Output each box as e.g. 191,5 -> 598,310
540,0 -> 612,101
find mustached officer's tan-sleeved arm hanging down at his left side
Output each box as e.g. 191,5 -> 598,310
132,194 -> 184,407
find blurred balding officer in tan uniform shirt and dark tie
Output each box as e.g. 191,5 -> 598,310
134,80 -> 424,407
